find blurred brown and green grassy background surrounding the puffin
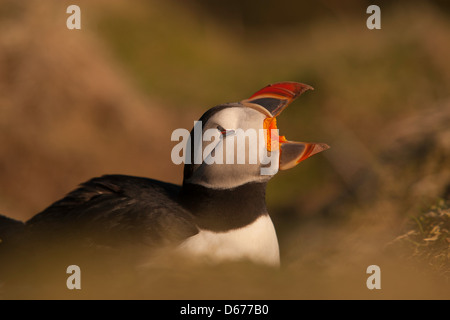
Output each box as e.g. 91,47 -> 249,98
0,0 -> 450,299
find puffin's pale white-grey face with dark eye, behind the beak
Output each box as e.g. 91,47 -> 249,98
186,107 -> 279,189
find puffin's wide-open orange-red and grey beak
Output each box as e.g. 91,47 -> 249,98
241,82 -> 330,170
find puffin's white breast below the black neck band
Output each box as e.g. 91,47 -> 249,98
179,215 -> 280,266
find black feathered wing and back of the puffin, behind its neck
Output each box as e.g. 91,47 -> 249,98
26,175 -> 198,246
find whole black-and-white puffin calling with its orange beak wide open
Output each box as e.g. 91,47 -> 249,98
0,82 -> 329,267
